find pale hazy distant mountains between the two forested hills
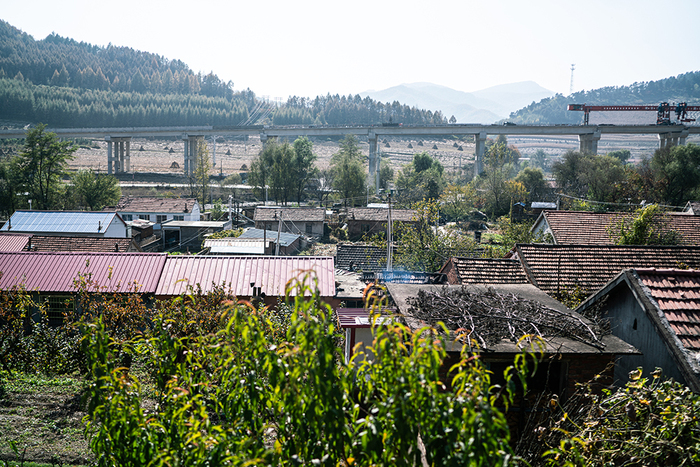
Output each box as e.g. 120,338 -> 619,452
360,81 -> 554,123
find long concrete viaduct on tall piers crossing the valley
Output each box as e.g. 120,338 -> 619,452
0,124 -> 700,188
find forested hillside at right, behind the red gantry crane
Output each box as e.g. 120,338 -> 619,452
509,71 -> 700,124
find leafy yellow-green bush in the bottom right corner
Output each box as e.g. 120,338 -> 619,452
538,368 -> 700,466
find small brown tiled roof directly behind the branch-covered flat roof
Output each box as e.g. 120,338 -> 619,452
442,257 -> 528,284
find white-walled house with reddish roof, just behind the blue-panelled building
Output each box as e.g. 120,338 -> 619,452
104,196 -> 201,230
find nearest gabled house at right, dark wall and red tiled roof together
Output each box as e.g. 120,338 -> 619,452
576,268 -> 700,392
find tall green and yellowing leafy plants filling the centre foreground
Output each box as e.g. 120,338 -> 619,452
78,280 -> 524,466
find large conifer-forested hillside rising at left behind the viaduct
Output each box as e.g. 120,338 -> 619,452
0,20 -> 445,127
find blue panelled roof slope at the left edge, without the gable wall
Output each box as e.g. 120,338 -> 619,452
0,211 -> 122,234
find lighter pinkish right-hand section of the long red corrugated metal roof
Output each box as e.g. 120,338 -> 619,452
156,256 -> 335,297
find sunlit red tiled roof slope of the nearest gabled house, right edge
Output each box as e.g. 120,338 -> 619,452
637,269 -> 700,351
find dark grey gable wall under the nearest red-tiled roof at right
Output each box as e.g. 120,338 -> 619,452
605,282 -> 686,384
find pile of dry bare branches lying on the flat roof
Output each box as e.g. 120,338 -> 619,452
408,287 -> 605,349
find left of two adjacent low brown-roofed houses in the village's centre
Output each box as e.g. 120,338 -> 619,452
253,206 -> 326,237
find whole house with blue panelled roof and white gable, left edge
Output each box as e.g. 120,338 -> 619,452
0,210 -> 131,239
